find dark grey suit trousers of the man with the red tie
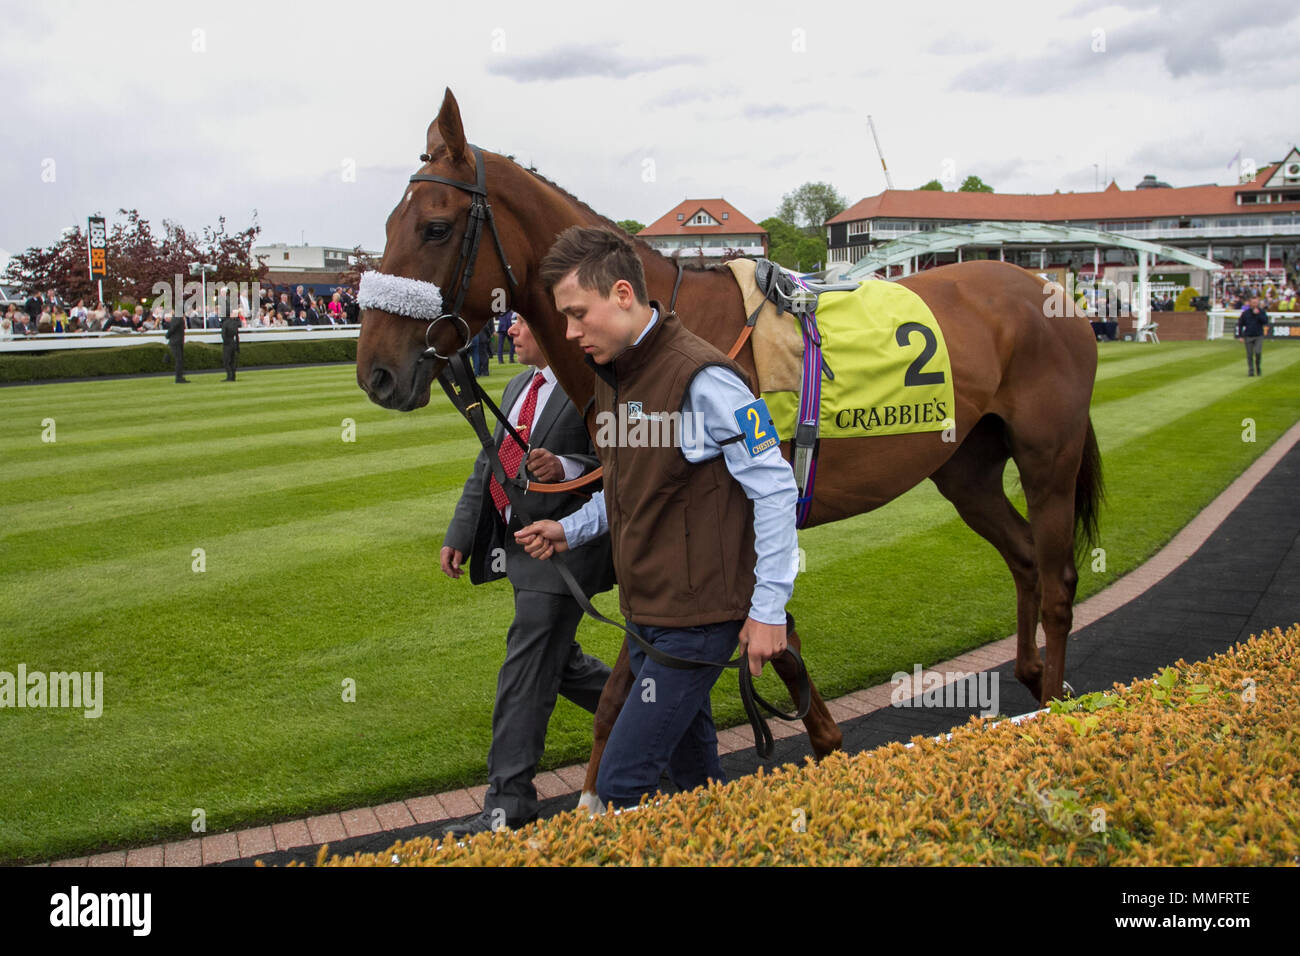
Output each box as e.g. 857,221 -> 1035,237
484,588 -> 610,825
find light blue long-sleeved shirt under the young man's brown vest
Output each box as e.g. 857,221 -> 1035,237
560,310 -> 798,624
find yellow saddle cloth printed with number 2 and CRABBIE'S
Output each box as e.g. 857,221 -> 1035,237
754,280 -> 956,438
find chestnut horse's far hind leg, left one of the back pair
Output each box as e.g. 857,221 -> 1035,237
931,415 -> 1043,700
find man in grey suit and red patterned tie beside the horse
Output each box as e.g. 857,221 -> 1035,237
441,316 -> 614,835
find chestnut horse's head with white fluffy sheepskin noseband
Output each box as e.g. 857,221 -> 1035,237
356,88 -> 523,411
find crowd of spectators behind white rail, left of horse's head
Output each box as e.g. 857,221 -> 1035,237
0,286 -> 360,339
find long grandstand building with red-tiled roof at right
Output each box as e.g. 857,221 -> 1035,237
826,147 -> 1300,306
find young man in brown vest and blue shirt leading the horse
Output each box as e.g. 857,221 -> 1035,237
516,226 -> 797,808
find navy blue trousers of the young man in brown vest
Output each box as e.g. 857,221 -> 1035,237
595,620 -> 745,808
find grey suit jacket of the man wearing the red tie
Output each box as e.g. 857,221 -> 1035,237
442,368 -> 614,594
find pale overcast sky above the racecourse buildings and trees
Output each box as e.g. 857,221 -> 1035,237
0,0 -> 1300,261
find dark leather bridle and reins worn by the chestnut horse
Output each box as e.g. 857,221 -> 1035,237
397,144 -> 813,760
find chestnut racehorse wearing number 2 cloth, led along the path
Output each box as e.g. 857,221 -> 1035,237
356,88 -> 1101,806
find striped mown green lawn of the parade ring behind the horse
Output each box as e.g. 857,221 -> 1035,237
0,342 -> 1300,861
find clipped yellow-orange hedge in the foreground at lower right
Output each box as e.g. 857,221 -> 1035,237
309,626 -> 1300,866
